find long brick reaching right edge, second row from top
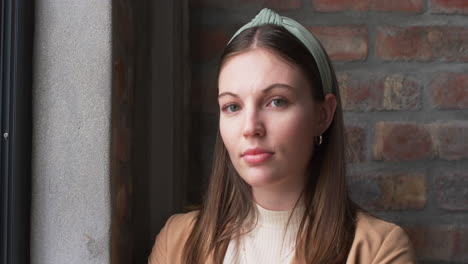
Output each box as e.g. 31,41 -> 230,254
376,26 -> 468,62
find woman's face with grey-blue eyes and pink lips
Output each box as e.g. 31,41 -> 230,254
218,48 -> 320,188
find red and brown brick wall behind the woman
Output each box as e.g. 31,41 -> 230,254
189,0 -> 468,263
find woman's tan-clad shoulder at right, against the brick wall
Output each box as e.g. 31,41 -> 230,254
347,212 -> 416,264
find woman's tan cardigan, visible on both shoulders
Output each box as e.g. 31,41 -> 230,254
148,211 -> 416,264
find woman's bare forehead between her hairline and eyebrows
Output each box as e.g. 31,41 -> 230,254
218,48 -> 307,93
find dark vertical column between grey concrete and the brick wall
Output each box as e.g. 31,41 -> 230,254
111,0 -> 189,264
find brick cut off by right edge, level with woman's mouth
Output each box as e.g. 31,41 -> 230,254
431,121 -> 468,160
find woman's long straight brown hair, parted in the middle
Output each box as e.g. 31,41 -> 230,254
182,25 -> 357,264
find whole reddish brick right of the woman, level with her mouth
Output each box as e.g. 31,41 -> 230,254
374,122 -> 433,161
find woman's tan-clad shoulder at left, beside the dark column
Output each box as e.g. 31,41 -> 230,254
148,211 -> 198,264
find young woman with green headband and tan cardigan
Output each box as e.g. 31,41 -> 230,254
149,9 -> 415,264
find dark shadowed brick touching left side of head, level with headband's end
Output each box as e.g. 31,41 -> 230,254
191,29 -> 230,62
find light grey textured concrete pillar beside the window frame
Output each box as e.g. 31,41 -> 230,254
31,0 -> 111,264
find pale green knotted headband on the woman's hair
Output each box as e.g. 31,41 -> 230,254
229,8 -> 333,94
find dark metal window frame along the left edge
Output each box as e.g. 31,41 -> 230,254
0,0 -> 34,264
